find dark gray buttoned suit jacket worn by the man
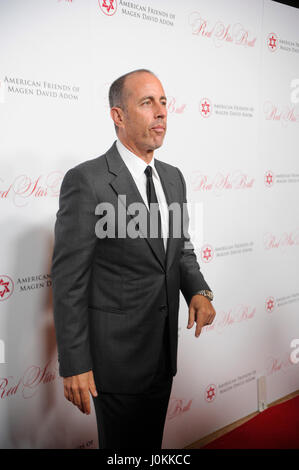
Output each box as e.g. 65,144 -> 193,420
52,142 -> 210,393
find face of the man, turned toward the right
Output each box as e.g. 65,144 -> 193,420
119,72 -> 167,153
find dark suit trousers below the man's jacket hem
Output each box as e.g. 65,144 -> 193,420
93,322 -> 173,449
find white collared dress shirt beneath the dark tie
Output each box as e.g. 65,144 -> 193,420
116,139 -> 169,252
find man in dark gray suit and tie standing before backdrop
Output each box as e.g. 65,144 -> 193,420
52,69 -> 215,448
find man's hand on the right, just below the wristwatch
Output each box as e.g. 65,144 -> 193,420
187,294 -> 216,337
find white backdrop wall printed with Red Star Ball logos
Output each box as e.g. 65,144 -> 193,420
0,0 -> 299,448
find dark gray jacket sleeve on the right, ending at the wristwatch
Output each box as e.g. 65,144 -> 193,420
177,168 -> 211,305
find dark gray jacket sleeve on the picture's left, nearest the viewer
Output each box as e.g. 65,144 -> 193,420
51,168 -> 97,377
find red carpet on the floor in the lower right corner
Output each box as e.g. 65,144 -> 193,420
202,396 -> 299,449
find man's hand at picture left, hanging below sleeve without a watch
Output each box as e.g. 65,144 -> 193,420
63,370 -> 98,415
